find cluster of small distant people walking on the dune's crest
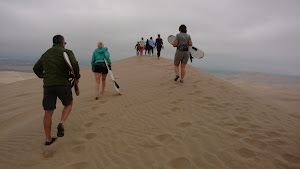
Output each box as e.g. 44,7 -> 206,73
135,34 -> 163,59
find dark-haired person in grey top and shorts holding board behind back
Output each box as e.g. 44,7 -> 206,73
173,25 -> 192,83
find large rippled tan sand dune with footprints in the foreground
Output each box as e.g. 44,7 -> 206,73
0,56 -> 300,169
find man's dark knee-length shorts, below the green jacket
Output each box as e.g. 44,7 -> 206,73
43,86 -> 73,110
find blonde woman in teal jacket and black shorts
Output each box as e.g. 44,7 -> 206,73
91,42 -> 111,100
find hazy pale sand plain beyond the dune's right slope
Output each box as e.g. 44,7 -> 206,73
216,73 -> 300,114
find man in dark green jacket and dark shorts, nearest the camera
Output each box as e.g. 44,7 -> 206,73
33,35 -> 80,145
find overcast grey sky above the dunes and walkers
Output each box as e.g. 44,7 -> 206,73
0,0 -> 300,75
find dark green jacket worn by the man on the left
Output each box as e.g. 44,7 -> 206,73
33,44 -> 80,87
